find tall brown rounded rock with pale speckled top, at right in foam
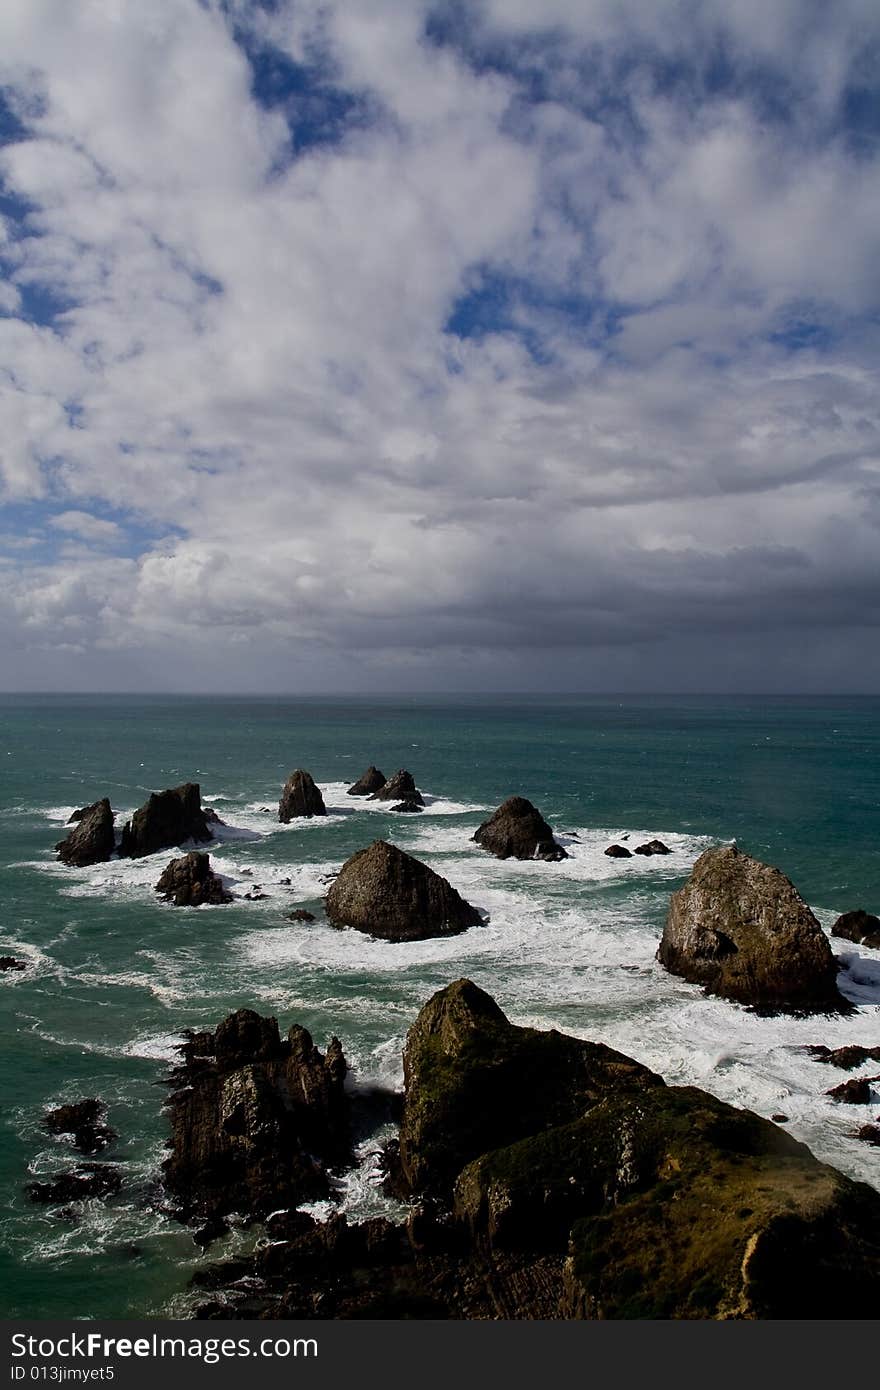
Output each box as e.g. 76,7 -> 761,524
658,845 -> 848,1013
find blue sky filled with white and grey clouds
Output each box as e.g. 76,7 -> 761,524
0,0 -> 880,694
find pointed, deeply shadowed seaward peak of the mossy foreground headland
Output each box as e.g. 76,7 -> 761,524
399,980 -> 662,1195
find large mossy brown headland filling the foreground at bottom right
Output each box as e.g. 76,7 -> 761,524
197,980 -> 880,1319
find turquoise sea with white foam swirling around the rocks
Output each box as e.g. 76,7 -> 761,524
0,696 -> 880,1318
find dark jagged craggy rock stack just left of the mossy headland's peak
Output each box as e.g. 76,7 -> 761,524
163,1009 -> 350,1220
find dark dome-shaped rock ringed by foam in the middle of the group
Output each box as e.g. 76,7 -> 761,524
325,840 -> 482,941
